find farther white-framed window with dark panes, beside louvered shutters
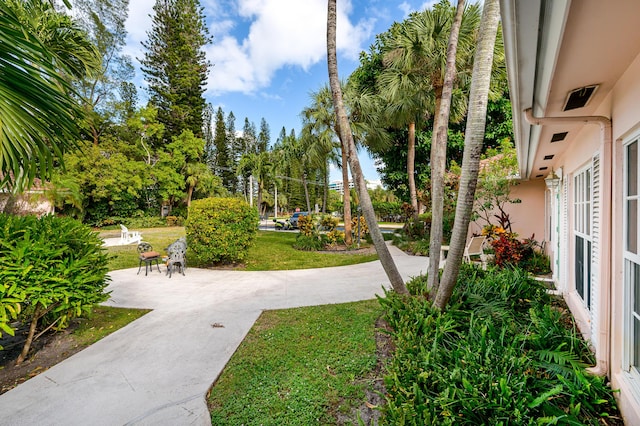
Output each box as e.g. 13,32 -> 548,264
573,167 -> 592,309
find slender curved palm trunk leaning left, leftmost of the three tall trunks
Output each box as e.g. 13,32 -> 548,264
327,0 -> 408,294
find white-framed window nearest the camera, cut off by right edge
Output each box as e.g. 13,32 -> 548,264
624,139 -> 640,374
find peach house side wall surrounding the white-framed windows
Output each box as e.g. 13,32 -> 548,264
536,49 -> 640,424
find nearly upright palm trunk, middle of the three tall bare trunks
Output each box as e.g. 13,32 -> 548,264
427,0 -> 464,297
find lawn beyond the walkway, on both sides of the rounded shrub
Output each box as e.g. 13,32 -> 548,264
101,227 -> 378,271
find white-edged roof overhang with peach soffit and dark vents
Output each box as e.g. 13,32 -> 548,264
500,0 -> 640,180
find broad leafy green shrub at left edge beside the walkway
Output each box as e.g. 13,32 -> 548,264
0,215 -> 108,363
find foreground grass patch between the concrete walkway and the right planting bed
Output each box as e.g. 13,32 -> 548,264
209,300 -> 382,426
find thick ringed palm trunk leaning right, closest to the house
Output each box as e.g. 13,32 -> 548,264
434,0 -> 500,310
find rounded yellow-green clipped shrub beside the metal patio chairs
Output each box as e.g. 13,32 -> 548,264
185,198 -> 259,266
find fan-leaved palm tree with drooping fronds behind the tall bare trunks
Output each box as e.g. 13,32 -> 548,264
377,0 -> 479,217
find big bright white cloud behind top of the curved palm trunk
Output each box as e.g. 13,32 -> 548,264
208,0 -> 372,93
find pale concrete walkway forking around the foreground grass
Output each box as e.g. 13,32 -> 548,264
0,247 -> 428,425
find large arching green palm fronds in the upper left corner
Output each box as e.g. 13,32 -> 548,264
0,0 -> 99,191
